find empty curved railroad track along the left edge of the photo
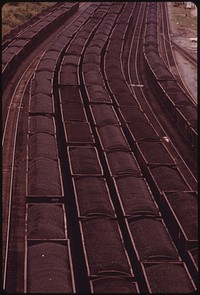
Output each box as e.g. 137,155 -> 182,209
2,2 -> 90,292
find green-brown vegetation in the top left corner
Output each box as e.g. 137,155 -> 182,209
1,2 -> 55,35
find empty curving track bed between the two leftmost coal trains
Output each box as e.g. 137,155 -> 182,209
2,3 -> 88,292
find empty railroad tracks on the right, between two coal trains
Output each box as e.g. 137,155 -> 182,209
125,2 -> 197,185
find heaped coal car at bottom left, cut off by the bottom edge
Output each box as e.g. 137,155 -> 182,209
25,240 -> 75,293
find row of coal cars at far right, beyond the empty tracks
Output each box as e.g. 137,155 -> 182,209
145,2 -> 197,154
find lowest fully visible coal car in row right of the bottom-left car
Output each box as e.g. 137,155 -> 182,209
79,216 -> 133,277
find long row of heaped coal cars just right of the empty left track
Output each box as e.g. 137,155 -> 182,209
24,2 -> 83,293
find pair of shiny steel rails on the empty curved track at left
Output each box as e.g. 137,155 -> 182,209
2,48 -> 46,289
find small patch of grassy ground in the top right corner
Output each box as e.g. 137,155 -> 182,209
172,4 -> 197,30
